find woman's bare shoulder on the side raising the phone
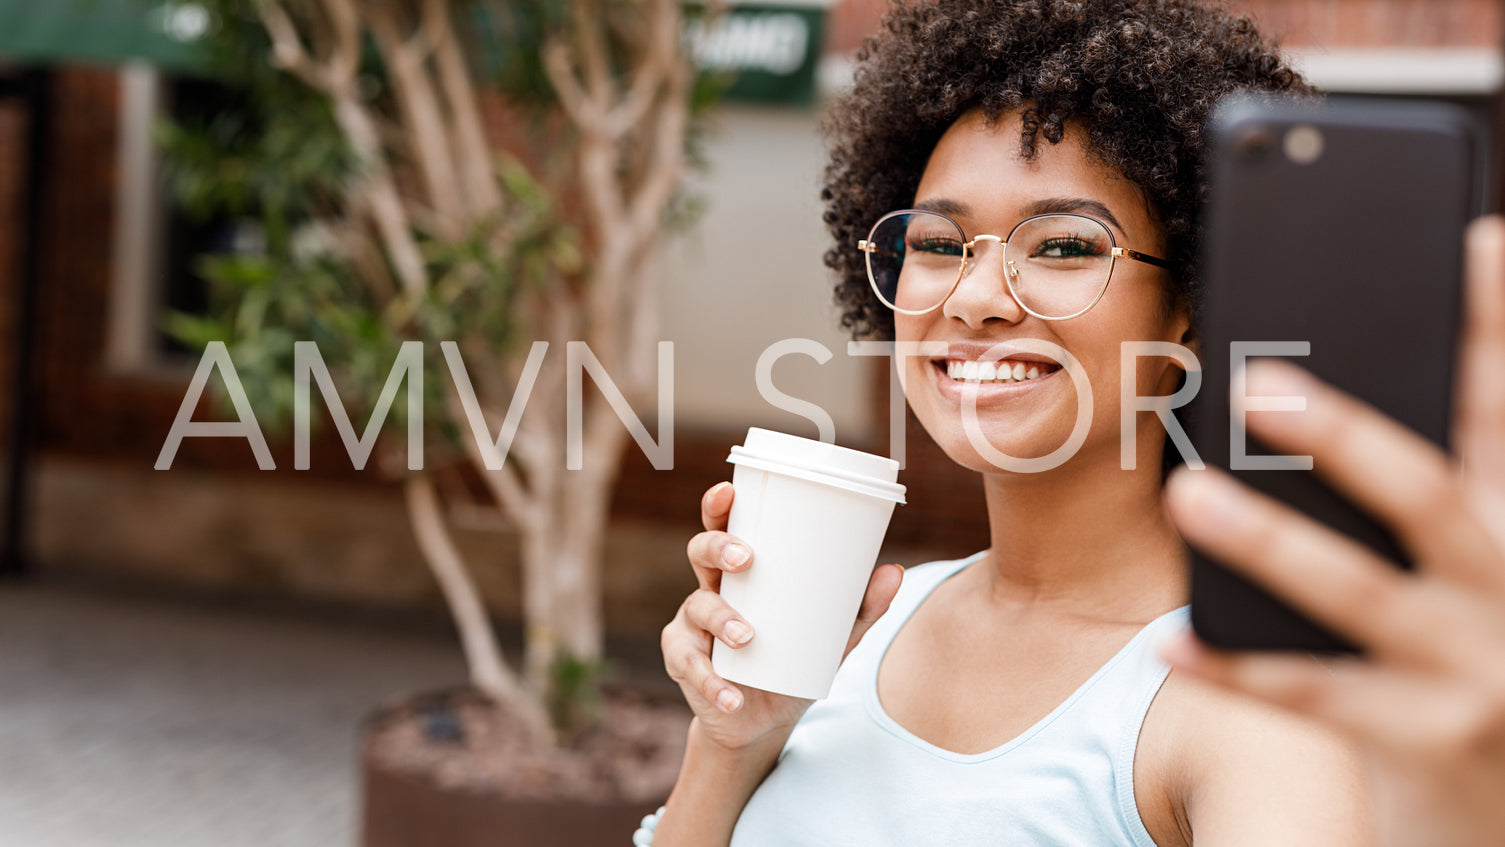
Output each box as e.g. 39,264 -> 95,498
1135,672 -> 1371,847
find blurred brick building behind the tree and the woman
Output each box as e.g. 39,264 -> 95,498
0,0 -> 1505,633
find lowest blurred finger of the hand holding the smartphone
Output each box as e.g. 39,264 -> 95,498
1160,632 -> 1494,761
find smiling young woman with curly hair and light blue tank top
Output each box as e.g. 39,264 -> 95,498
653,0 -> 1367,847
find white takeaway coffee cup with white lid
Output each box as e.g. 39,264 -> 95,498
710,427 -> 905,700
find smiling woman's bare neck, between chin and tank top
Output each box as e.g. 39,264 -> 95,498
984,451 -> 1187,620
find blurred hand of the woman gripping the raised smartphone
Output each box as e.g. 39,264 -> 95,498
1166,218 -> 1505,847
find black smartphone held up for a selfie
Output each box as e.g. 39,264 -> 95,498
1189,95 -> 1479,653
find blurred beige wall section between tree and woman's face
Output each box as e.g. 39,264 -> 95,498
661,105 -> 873,442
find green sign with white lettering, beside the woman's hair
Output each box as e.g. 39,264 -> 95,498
685,2 -> 826,104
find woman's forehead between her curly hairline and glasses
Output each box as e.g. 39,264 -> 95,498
915,111 -> 1160,242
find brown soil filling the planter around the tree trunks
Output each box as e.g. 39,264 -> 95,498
366,688 -> 691,808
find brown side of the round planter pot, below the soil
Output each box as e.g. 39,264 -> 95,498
361,758 -> 653,847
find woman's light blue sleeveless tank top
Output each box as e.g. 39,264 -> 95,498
731,554 -> 1187,847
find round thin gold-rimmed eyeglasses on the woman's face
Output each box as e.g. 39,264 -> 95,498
856,209 -> 1171,320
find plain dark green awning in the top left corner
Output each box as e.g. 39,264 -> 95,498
0,0 -> 214,69
